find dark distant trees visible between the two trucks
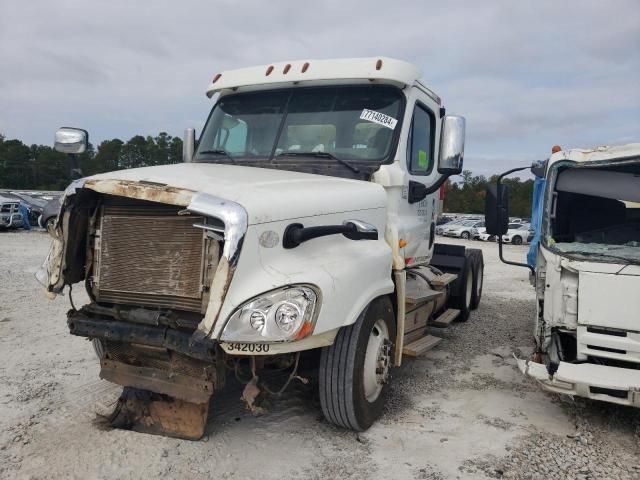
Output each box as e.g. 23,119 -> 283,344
444,170 -> 533,217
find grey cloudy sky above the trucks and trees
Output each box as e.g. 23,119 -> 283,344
0,0 -> 640,174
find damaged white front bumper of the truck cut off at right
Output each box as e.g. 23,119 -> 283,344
516,358 -> 640,407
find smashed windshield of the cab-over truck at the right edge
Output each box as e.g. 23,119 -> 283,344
550,164 -> 640,264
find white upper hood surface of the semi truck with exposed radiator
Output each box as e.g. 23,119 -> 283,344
85,163 -> 386,225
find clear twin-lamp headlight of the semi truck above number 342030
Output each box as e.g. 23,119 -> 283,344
220,285 -> 319,342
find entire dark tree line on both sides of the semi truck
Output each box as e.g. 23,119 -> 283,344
0,132 -> 533,217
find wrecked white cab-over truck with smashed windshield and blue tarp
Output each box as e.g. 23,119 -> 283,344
486,143 -> 640,407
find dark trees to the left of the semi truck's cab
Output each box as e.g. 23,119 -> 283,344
0,132 -> 182,190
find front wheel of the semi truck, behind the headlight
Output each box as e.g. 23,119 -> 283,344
318,297 -> 396,432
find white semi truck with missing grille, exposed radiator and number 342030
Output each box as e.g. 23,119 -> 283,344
38,58 -> 483,438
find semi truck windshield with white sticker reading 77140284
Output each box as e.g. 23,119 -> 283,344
194,85 -> 404,174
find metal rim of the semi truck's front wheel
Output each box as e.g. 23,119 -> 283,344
363,318 -> 391,403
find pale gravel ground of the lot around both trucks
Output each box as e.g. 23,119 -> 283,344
0,231 -> 640,480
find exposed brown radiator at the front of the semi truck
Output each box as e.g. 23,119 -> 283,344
94,202 -> 205,312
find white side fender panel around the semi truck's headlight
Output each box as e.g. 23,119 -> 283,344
212,208 -> 394,351
